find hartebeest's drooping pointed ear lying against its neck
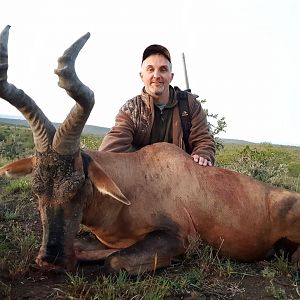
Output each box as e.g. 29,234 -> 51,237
88,160 -> 131,205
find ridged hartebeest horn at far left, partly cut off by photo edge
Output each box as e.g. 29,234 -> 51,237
0,25 -> 55,152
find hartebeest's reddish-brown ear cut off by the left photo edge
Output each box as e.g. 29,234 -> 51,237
0,156 -> 35,177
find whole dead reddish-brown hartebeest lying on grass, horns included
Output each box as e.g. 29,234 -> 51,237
0,27 -> 300,273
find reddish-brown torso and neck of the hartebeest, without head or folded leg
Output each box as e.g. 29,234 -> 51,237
2,144 -> 300,270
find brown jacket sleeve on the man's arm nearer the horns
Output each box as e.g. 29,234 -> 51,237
99,109 -> 135,152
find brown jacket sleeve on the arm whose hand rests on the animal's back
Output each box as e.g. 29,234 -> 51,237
189,98 -> 216,164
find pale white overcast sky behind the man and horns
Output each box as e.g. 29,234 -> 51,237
0,0 -> 300,145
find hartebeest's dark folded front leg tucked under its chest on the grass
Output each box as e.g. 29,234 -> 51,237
104,231 -> 184,275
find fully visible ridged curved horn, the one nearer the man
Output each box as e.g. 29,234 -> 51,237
53,33 -> 95,155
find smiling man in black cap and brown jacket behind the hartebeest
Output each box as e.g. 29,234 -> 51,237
99,45 -> 215,166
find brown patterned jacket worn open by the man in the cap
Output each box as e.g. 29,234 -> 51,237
99,87 -> 215,163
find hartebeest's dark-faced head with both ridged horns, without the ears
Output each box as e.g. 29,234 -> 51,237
0,26 -> 126,269
